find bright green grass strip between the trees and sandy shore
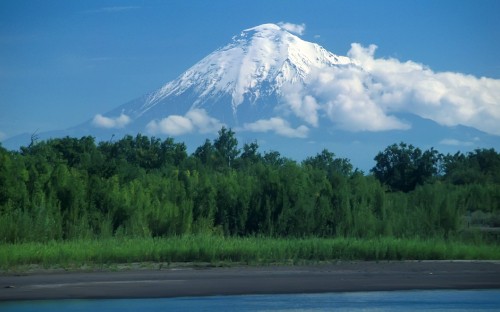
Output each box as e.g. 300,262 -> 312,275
0,236 -> 500,270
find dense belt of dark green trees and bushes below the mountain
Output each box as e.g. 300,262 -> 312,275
0,128 -> 500,243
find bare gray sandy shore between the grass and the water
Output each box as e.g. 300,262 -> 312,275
0,261 -> 500,301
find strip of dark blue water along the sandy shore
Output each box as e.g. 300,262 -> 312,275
0,290 -> 500,312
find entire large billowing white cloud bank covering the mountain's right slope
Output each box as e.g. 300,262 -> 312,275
281,43 -> 500,135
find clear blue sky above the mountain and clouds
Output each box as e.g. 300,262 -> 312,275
0,0 -> 500,140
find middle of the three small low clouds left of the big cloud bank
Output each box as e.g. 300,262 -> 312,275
146,109 -> 224,135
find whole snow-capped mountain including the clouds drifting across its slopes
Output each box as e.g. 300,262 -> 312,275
4,24 -> 500,170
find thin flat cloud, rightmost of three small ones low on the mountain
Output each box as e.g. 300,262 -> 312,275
243,117 -> 309,138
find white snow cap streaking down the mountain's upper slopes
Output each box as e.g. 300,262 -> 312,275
134,24 -> 352,116
